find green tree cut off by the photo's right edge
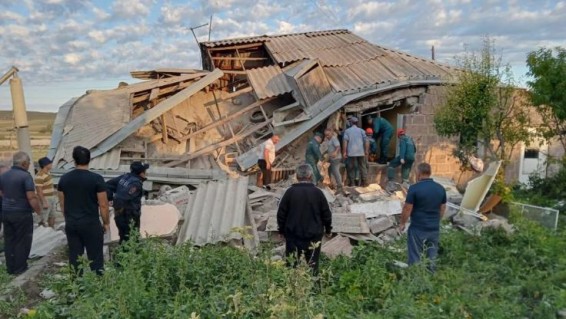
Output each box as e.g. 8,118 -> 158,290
527,47 -> 566,149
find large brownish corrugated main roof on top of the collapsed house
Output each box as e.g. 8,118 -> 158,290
206,30 -> 456,91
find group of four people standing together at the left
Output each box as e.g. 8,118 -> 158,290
0,146 -> 149,275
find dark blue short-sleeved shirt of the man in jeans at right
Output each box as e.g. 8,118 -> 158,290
406,178 -> 446,231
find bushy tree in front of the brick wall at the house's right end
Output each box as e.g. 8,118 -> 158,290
434,37 -> 531,172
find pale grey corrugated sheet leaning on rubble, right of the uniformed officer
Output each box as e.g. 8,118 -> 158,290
177,177 -> 249,246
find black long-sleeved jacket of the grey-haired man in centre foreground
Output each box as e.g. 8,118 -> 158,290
277,183 -> 332,239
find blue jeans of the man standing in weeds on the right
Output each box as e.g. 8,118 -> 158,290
407,226 -> 440,272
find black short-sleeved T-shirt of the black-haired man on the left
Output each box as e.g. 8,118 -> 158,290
58,169 -> 106,223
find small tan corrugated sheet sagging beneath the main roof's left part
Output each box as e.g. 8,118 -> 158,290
246,65 -> 292,100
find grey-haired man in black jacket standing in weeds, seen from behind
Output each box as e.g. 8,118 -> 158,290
277,164 -> 332,276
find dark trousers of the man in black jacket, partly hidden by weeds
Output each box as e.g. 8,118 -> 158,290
285,237 -> 322,276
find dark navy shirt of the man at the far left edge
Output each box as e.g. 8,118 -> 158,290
0,167 -> 35,213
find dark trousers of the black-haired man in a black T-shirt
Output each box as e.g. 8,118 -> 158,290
65,222 -> 104,275
